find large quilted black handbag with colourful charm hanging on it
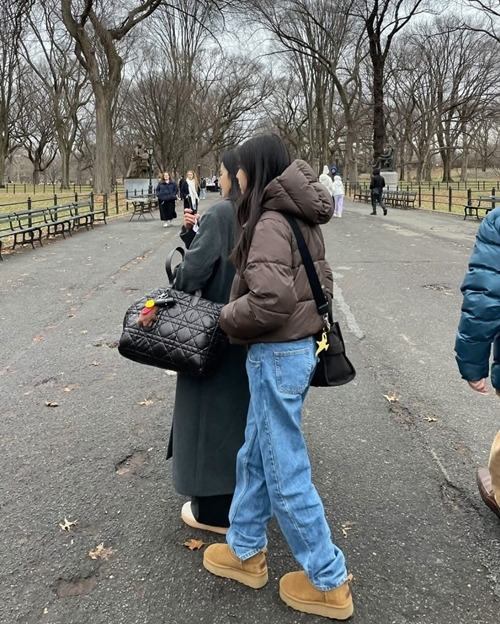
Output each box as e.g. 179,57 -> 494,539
118,247 -> 229,377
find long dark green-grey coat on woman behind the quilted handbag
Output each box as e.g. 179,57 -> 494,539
167,200 -> 250,496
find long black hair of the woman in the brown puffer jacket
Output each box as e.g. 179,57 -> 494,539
231,134 -> 291,272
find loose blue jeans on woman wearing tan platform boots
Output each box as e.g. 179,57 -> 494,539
227,337 -> 347,591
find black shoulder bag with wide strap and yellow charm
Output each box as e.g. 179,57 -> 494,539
283,214 -> 356,387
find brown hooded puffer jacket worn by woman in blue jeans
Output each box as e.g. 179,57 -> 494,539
220,160 -> 333,344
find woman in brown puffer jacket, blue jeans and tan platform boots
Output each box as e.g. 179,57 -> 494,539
203,135 -> 353,619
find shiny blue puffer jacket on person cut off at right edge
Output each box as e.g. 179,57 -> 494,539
455,208 -> 500,390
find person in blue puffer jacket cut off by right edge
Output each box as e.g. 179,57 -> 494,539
455,208 -> 500,518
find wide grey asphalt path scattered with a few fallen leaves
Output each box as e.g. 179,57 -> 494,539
0,196 -> 500,624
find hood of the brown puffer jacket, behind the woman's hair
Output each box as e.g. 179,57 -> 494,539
262,160 -> 333,225
